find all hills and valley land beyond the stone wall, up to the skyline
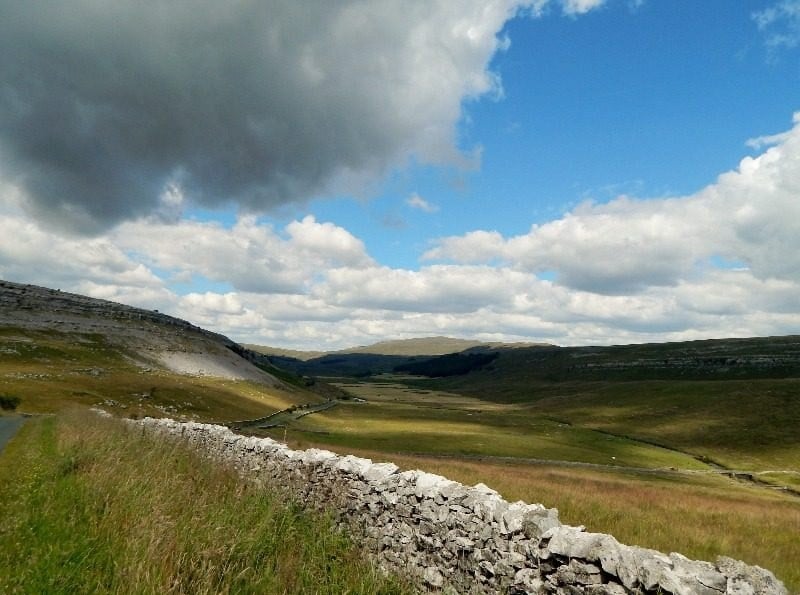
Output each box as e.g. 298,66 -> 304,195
0,282 -> 800,590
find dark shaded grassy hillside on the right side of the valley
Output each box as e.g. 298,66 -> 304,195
398,337 -> 800,484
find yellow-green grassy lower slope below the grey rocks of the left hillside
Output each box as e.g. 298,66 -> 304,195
0,327 -> 317,421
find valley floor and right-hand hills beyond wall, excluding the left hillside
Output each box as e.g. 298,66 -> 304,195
247,336 -> 800,589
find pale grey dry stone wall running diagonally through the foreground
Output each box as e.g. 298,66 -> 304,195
132,418 -> 787,595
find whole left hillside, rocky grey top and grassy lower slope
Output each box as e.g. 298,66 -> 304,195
0,281 -> 317,420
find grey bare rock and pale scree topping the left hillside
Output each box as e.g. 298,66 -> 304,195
0,281 -> 280,386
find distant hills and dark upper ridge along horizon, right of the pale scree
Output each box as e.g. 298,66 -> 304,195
248,335 -> 800,382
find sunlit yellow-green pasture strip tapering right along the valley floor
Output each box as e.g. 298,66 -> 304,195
274,382 -> 708,469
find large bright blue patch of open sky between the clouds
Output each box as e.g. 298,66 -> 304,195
272,0 -> 800,268
